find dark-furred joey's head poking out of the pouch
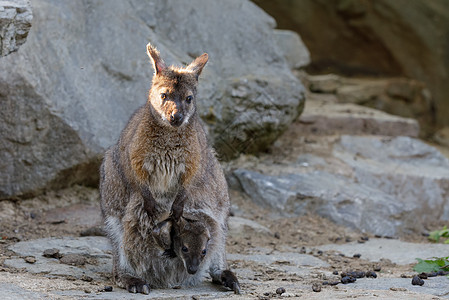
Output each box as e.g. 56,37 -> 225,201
173,218 -> 211,274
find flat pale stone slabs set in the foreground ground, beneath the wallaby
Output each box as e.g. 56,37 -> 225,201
0,232 -> 449,299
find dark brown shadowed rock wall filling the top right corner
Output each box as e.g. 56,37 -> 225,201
253,0 -> 449,126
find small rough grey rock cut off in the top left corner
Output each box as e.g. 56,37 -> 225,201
0,0 -> 33,56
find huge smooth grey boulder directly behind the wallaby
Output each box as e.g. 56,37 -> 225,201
0,0 -> 304,198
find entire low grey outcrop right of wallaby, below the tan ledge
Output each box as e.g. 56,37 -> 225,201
233,136 -> 449,236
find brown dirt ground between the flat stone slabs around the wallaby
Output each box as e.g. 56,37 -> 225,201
0,182 -> 442,299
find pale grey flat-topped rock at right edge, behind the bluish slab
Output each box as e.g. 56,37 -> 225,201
334,136 -> 449,223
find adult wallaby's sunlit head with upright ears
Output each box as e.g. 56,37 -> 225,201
147,44 -> 208,129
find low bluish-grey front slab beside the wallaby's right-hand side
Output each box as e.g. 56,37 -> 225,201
234,169 -> 403,236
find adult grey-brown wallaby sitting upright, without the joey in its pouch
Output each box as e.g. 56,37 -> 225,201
100,44 -> 238,293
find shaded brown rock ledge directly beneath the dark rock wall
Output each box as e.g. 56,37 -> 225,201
298,72 -> 436,138
